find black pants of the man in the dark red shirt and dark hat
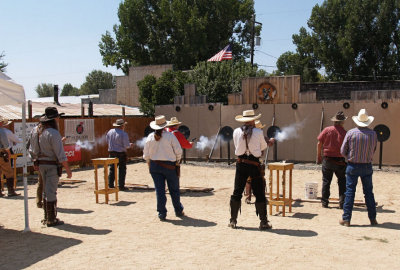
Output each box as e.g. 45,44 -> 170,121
321,157 -> 346,204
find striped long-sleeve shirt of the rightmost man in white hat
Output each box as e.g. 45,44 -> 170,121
340,127 -> 377,163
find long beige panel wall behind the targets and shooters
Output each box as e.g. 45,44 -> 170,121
156,102 -> 400,165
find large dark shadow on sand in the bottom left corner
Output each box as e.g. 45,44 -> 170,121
0,227 -> 82,269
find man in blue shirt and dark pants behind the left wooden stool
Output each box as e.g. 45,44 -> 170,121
106,119 -> 133,191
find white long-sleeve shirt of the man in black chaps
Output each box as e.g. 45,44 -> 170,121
233,127 -> 268,157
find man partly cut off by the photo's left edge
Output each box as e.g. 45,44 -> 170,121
0,116 -> 20,197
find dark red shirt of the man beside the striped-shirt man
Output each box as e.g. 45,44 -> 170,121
317,125 -> 346,157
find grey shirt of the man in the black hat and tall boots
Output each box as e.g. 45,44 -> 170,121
29,128 -> 68,163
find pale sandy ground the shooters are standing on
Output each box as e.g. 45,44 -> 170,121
0,163 -> 400,269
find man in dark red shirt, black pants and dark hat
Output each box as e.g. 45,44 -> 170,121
317,111 -> 347,209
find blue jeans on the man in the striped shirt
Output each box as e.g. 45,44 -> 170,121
343,162 -> 376,221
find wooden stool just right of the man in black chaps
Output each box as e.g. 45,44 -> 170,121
268,162 -> 293,216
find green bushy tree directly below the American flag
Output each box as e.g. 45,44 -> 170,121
189,60 -> 266,102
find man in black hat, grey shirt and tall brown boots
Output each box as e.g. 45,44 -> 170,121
29,107 -> 72,227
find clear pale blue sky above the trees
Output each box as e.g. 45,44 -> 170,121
0,0 -> 323,99
